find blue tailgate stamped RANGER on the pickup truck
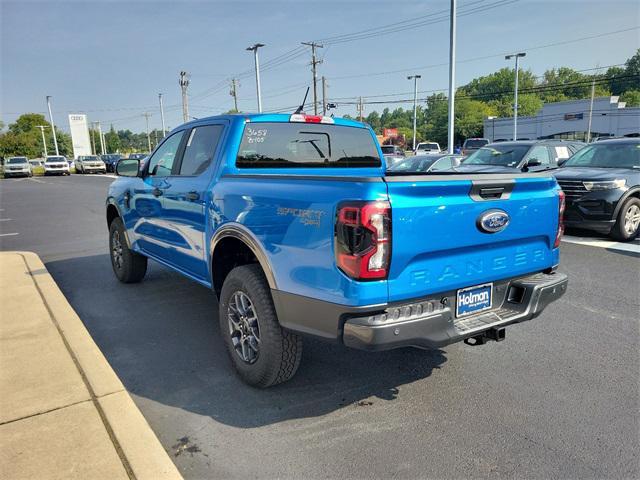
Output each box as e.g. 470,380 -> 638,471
385,173 -> 558,302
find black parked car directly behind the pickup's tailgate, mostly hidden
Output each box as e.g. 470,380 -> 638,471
462,140 -> 585,172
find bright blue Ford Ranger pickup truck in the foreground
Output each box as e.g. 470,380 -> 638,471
106,114 -> 567,387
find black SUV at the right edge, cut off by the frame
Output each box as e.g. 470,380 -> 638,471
554,138 -> 640,241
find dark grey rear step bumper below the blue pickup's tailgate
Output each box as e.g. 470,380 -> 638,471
343,273 -> 568,350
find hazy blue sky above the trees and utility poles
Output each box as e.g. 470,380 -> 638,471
0,0 -> 640,131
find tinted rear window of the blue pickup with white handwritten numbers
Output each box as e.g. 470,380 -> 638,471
236,122 -> 382,168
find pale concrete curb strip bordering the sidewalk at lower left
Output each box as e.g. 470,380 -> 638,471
7,252 -> 182,480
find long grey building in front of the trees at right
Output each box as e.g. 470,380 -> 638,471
484,97 -> 640,142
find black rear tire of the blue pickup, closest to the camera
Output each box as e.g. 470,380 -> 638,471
219,264 -> 302,388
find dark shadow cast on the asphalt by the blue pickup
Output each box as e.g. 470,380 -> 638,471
47,254 -> 446,428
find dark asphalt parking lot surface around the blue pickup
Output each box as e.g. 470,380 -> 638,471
0,176 -> 640,478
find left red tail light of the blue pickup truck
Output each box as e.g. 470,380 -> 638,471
335,202 -> 391,280
